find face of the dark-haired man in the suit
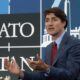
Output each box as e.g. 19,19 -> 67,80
45,13 -> 66,36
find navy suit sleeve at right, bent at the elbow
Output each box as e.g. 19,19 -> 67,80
49,44 -> 80,80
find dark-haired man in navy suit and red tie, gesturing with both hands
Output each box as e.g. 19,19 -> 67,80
5,7 -> 80,80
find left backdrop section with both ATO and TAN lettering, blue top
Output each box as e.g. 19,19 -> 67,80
0,0 -> 40,80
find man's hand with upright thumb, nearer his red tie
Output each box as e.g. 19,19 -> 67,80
26,54 -> 49,71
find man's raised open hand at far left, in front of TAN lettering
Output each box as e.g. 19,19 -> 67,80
4,59 -> 22,76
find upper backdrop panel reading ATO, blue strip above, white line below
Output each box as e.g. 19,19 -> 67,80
0,0 -> 40,51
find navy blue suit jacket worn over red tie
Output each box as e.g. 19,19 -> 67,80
23,33 -> 80,80
